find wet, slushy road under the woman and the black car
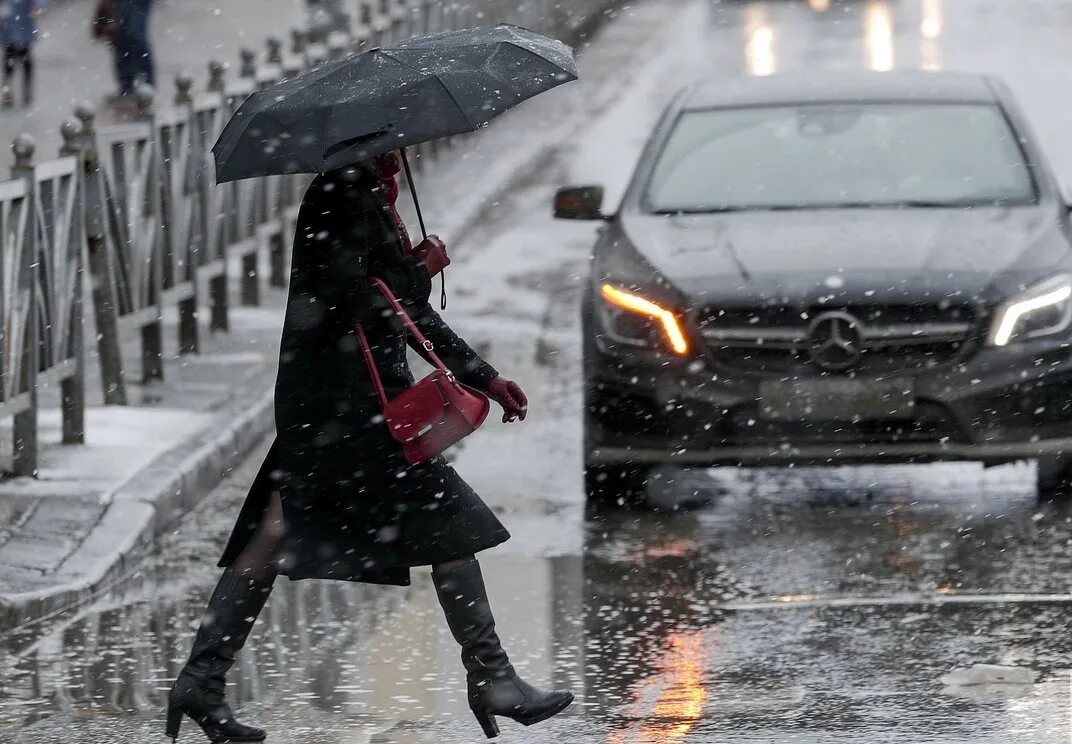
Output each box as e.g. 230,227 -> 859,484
0,0 -> 1072,744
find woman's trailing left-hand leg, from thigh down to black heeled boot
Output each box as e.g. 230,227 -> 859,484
167,492 -> 284,742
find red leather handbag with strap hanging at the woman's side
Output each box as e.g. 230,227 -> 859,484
356,277 -> 491,465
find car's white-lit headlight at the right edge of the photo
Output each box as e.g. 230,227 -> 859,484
988,273 -> 1072,346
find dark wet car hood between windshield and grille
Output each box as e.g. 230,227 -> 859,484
621,206 -> 1070,304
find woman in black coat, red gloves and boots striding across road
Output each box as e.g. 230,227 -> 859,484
167,152 -> 574,742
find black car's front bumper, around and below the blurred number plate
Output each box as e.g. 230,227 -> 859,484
589,334 -> 1072,465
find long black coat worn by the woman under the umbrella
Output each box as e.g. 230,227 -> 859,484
220,168 -> 509,584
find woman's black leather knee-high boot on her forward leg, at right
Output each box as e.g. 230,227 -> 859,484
432,560 -> 574,739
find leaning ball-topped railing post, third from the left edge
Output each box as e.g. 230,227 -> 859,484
74,103 -> 126,405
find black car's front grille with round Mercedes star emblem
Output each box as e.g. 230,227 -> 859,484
700,303 -> 974,376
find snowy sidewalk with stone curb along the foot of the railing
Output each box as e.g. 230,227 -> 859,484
0,0 -> 681,633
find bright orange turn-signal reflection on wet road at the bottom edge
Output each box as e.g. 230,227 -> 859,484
607,630 -> 708,744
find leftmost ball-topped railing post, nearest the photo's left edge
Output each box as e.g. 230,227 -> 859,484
11,134 -> 41,476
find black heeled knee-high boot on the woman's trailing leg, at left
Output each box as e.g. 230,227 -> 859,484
167,568 -> 274,742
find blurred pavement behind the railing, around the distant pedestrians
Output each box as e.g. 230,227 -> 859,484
0,0 -> 304,165
